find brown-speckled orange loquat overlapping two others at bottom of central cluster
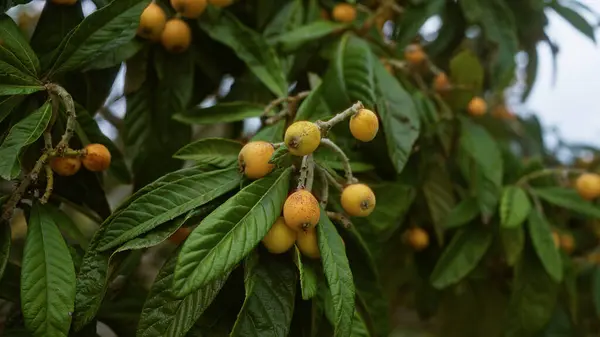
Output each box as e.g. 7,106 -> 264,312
283,190 -> 321,230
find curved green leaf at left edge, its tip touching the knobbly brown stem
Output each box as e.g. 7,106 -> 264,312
0,102 -> 52,180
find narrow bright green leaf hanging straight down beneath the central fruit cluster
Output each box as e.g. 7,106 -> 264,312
317,209 -> 355,337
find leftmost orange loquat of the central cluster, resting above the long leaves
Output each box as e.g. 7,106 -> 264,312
238,141 -> 275,179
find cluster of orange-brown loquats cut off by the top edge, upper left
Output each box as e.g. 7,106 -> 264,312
137,0 -> 233,53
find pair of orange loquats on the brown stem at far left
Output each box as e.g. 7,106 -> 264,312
50,143 -> 111,177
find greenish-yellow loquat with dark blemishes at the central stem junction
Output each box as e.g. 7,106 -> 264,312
283,121 -> 321,157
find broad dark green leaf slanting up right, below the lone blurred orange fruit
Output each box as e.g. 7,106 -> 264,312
431,227 -> 492,289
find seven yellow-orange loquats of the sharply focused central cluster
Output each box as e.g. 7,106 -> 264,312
238,108 -> 379,259
